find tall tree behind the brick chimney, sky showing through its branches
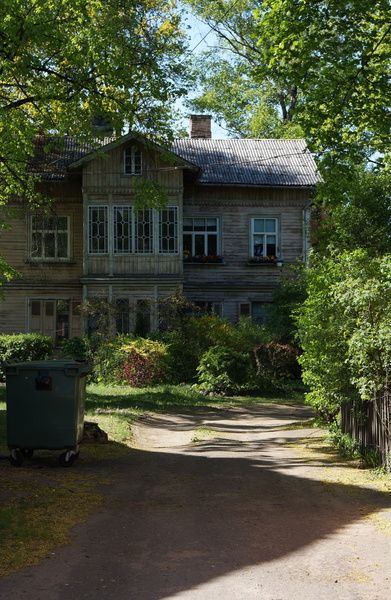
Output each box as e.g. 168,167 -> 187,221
186,0 -> 301,137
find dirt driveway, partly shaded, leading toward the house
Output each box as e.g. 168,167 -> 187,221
0,405 -> 391,600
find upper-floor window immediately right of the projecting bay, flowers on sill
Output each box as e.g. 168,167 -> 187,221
183,217 -> 219,256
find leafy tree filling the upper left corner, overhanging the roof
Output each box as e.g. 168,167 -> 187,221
0,0 -> 190,203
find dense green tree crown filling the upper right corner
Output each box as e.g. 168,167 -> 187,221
257,0 -> 391,169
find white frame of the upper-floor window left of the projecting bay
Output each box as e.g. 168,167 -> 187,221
29,214 -> 71,262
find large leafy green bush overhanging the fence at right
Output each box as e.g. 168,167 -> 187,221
297,250 -> 391,416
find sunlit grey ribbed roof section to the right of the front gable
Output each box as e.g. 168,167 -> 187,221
172,139 -> 321,187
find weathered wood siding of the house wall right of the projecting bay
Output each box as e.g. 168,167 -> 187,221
183,186 -> 309,320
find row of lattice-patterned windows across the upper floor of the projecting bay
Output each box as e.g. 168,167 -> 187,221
88,205 -> 178,254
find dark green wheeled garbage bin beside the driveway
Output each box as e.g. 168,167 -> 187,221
4,360 -> 88,467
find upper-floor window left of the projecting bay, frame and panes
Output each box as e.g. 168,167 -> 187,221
30,215 -> 70,261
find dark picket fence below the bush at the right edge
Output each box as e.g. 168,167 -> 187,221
341,385 -> 391,470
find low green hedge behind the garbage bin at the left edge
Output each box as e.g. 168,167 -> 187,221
0,333 -> 53,376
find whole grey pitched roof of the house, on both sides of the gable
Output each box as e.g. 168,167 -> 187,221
28,134 -> 321,187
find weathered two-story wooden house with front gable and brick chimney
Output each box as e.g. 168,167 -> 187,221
0,115 -> 319,343
